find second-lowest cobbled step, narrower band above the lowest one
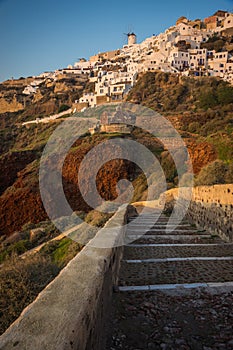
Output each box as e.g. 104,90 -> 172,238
124,244 -> 233,260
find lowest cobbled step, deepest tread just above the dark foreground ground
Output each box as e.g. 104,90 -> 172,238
119,260 -> 233,286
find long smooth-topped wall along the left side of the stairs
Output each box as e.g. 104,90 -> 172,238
0,207 -> 128,350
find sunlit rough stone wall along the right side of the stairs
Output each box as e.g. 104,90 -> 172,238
163,184 -> 233,242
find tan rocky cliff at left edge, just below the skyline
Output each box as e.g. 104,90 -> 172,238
0,74 -> 88,118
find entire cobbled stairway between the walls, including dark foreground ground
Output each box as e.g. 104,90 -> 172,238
106,212 -> 233,350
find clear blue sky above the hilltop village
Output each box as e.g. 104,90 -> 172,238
0,0 -> 233,81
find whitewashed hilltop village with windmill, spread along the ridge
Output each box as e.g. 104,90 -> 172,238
19,10 -> 233,111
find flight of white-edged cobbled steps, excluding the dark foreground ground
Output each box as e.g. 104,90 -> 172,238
119,213 -> 233,291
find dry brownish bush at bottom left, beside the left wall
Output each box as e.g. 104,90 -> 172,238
0,254 -> 60,333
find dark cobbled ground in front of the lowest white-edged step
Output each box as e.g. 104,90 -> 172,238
106,289 -> 233,350
